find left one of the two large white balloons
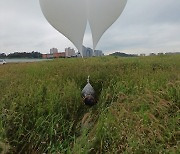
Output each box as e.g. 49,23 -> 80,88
40,0 -> 87,53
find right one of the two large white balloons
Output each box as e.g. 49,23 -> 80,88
87,0 -> 127,49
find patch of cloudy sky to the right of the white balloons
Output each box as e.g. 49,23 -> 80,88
98,0 -> 180,53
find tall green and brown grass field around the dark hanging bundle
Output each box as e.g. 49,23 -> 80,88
0,55 -> 180,154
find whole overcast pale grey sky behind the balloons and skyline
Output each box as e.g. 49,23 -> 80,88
0,0 -> 180,54
